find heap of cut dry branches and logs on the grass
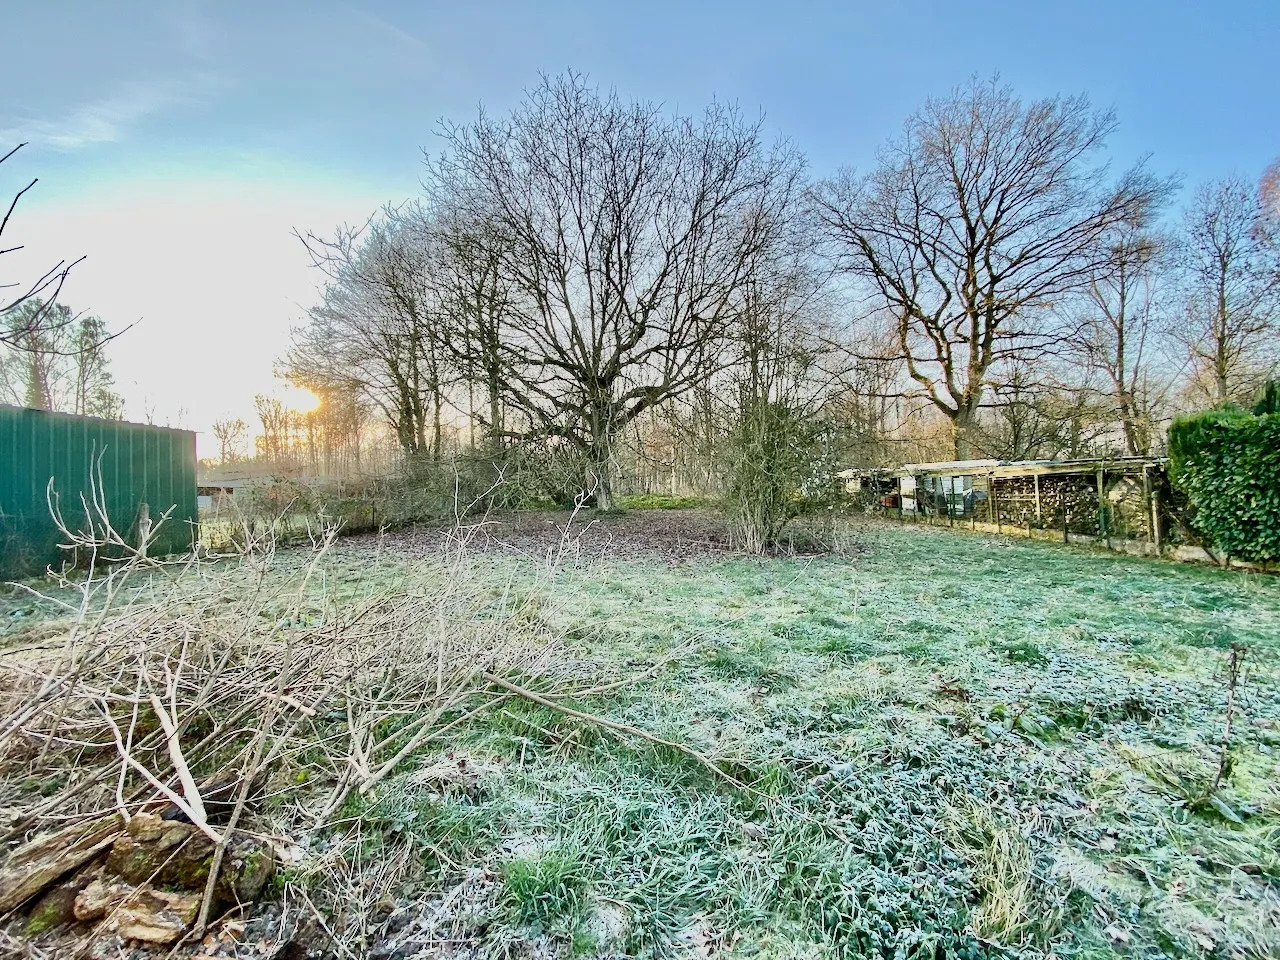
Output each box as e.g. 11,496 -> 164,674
0,512 -> 570,956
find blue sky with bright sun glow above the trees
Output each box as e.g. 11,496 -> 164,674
0,0 -> 1280,456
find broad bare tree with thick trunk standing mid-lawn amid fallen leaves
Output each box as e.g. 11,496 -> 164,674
429,73 -> 801,507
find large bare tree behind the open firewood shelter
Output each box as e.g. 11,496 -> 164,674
817,81 -> 1169,458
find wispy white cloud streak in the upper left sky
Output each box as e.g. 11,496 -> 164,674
0,76 -> 218,151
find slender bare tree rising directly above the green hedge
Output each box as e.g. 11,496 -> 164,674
1175,177 -> 1280,404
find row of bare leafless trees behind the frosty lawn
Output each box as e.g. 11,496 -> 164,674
275,73 -> 1280,507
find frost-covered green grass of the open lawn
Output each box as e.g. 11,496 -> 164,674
2,511 -> 1280,957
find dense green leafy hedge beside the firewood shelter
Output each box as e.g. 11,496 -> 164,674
1169,410 -> 1280,561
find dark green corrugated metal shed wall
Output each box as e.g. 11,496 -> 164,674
0,404 -> 197,579
